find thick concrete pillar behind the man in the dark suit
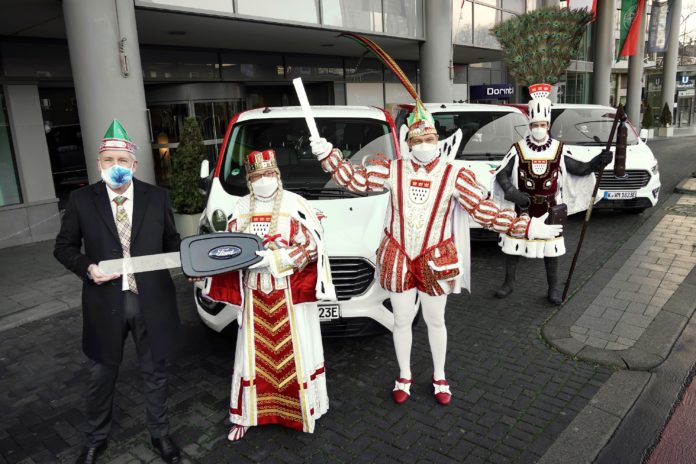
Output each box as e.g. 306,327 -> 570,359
63,0 -> 155,183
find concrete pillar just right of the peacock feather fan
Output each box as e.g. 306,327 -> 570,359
592,0 -> 615,105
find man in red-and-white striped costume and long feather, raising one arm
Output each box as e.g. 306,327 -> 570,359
310,34 -> 561,405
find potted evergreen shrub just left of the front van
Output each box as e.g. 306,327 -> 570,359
170,118 -> 206,237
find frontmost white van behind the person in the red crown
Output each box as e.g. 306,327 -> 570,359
195,106 -> 398,336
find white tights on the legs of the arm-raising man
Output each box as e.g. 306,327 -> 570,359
389,288 -> 447,380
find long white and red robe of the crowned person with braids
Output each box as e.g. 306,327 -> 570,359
201,191 -> 335,433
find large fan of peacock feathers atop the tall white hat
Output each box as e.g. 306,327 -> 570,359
491,7 -> 592,85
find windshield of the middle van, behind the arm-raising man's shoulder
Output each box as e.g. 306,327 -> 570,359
433,111 -> 529,160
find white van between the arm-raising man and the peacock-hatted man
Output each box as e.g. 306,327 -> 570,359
396,103 -> 529,240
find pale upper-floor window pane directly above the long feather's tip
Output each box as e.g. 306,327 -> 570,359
321,0 -> 382,32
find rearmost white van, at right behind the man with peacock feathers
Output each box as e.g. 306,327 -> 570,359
551,104 -> 660,213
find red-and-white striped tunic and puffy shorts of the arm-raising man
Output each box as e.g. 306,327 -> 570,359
322,149 -> 529,295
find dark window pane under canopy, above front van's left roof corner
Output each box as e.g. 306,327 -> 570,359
220,52 -> 285,81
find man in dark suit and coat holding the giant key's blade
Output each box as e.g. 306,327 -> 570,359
53,120 -> 181,463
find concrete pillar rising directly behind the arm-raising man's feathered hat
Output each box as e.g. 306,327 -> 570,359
420,0 -> 454,103
